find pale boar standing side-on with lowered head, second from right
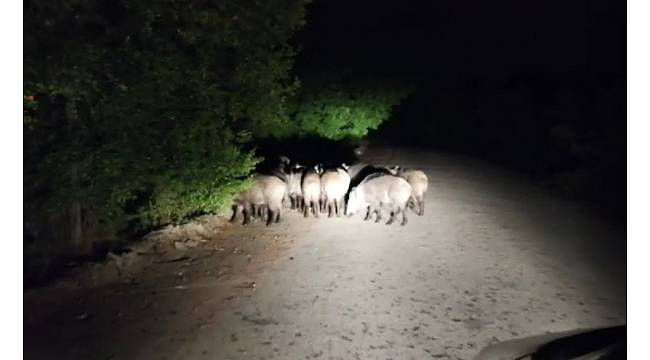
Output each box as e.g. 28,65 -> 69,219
346,174 -> 412,225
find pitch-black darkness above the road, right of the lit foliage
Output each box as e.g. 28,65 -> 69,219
294,0 -> 626,215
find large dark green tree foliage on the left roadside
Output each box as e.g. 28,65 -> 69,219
23,0 -> 305,249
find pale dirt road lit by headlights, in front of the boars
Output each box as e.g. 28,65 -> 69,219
24,148 -> 626,360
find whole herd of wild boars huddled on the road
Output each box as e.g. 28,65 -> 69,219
231,156 -> 429,225
